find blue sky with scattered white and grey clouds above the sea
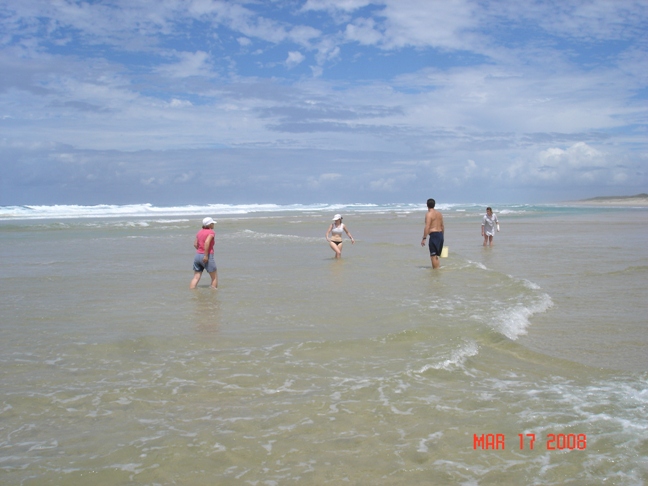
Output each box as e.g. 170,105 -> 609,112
0,0 -> 648,206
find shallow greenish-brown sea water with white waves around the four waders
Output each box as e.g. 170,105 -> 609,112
0,202 -> 648,485
